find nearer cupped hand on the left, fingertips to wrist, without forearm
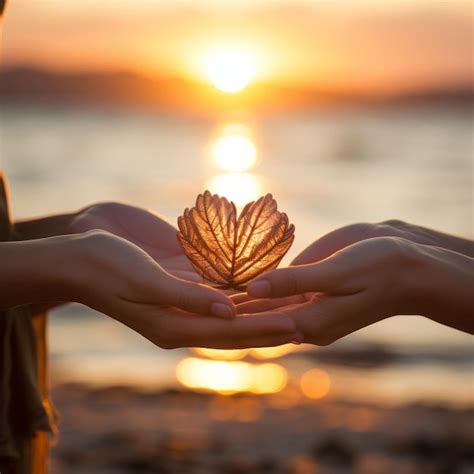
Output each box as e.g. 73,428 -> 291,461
67,231 -> 300,349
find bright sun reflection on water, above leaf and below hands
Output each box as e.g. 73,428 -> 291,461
183,123 -> 306,400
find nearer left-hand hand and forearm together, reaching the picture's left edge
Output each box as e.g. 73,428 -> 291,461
0,231 -> 298,349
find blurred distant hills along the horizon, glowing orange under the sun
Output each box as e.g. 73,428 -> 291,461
0,68 -> 474,116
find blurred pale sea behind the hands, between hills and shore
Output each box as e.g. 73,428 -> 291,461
0,106 -> 473,405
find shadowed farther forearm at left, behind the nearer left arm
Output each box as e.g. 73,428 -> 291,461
15,213 -> 77,240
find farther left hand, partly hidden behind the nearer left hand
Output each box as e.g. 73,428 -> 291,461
66,202 -> 198,282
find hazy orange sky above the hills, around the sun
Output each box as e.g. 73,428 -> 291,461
2,0 -> 473,92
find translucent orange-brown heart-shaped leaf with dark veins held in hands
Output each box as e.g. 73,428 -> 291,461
178,191 -> 295,290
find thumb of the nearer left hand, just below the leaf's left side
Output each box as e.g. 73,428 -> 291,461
158,272 -> 236,319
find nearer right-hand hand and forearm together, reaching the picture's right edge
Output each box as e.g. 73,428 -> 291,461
238,237 -> 474,345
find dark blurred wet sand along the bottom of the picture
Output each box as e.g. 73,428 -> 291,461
51,385 -> 474,474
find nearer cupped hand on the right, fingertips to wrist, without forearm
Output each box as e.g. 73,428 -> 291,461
237,237 -> 428,345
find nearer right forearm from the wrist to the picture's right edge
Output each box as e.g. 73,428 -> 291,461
412,245 -> 474,334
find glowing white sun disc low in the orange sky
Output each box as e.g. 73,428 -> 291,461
205,49 -> 255,94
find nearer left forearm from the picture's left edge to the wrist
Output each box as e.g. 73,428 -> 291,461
0,236 -> 75,309
